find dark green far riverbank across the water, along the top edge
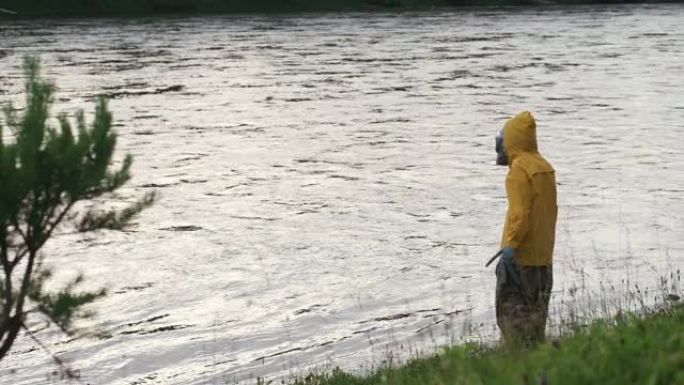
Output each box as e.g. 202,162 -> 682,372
0,0 -> 680,17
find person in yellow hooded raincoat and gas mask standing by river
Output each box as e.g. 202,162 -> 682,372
495,111 -> 558,345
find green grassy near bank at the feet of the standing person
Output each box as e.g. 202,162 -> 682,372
294,304 -> 684,385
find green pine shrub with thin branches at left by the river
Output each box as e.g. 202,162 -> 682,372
0,57 -> 154,368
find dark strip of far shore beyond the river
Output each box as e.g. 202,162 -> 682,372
0,0 -> 684,20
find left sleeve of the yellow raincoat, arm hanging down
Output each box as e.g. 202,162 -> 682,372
504,164 -> 532,249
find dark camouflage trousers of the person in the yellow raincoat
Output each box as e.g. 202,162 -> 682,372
496,261 -> 553,346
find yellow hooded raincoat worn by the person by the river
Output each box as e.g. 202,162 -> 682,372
501,111 -> 558,266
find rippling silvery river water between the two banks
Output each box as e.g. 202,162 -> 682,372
0,5 -> 684,385
